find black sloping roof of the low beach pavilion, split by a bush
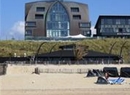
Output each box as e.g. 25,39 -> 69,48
37,50 -> 120,59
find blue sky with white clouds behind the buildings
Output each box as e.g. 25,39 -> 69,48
0,0 -> 130,40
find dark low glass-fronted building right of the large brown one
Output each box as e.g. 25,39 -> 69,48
94,15 -> 130,38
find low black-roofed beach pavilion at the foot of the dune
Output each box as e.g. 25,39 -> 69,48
36,44 -> 121,64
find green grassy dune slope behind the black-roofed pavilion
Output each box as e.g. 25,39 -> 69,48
0,38 -> 130,63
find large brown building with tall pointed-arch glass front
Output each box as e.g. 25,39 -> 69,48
25,0 -> 91,40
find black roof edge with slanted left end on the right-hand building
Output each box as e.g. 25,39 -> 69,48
95,15 -> 130,28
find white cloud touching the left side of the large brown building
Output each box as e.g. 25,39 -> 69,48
10,21 -> 25,39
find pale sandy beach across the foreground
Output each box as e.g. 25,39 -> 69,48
0,65 -> 130,95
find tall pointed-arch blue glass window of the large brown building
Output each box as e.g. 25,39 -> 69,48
46,2 -> 70,37
